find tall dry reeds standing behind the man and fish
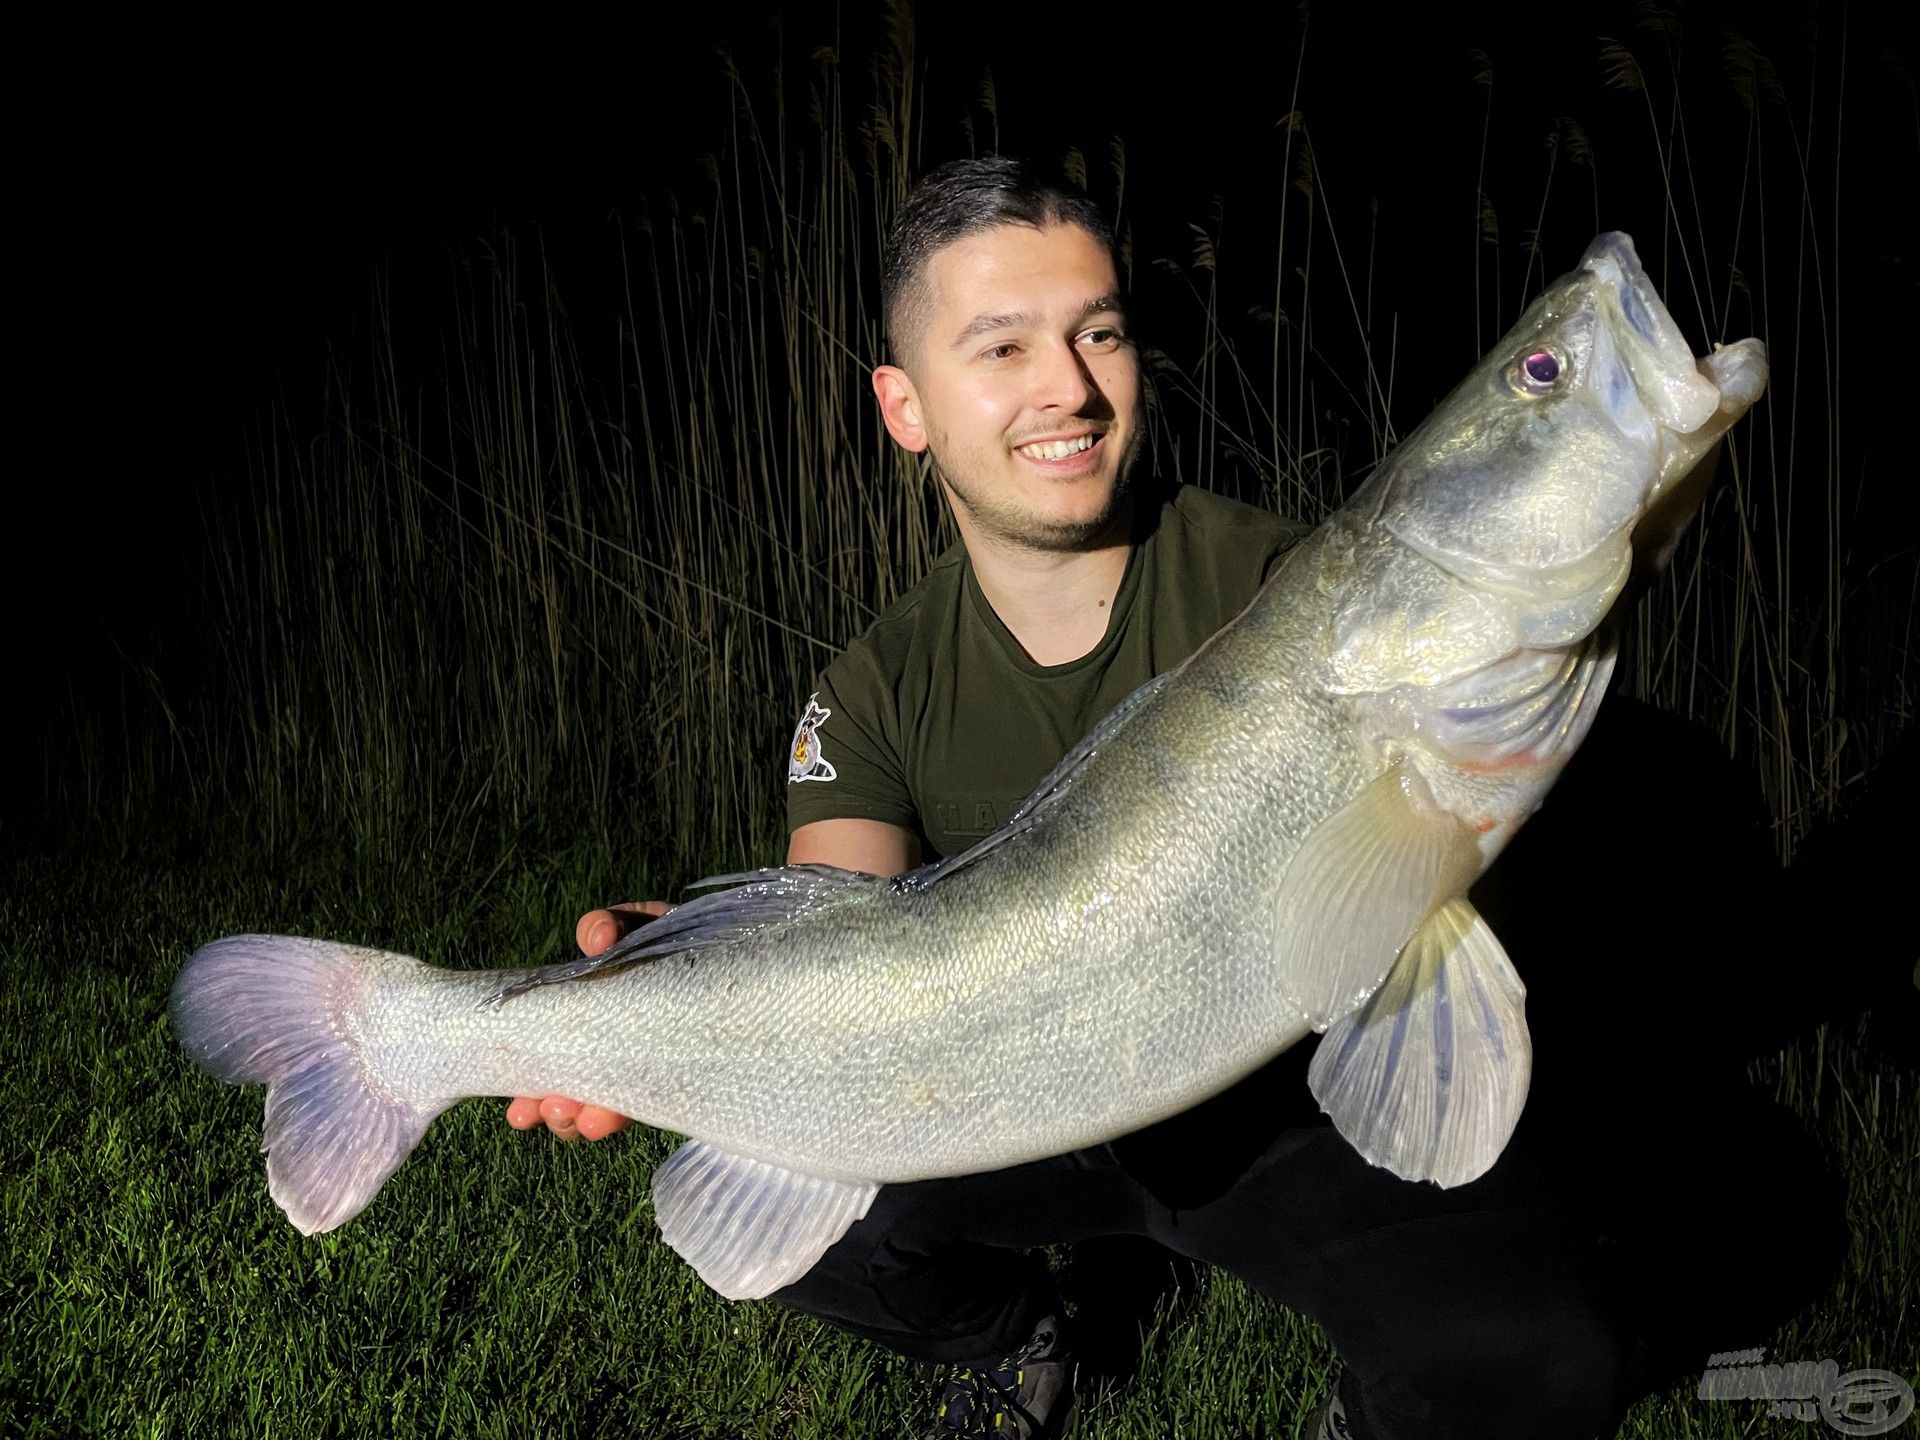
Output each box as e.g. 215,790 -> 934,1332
56,10 -> 1914,890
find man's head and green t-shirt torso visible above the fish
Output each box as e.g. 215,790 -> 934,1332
787,173 -> 1304,874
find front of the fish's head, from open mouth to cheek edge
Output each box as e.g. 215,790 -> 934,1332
1365,232 -> 1766,641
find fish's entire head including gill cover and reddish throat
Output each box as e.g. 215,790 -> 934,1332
1319,234 -> 1766,829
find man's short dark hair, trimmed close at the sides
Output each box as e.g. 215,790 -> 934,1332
879,156 -> 1114,368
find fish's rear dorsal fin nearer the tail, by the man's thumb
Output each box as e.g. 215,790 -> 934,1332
482,864 -> 891,1004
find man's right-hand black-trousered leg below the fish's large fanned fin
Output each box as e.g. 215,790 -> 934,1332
1160,1129 -> 1630,1440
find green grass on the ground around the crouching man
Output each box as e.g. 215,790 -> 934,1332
0,849 -> 1920,1440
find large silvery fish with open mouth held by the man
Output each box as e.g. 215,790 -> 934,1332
171,234 -> 1766,1298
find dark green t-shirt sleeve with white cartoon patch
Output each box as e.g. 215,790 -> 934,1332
787,651 -> 920,833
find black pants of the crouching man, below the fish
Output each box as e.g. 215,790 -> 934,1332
774,1066 -> 1626,1440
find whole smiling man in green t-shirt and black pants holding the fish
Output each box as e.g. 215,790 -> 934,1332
509,159 -> 1622,1440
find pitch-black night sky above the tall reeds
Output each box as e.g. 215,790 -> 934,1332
4,4 -> 1916,817
